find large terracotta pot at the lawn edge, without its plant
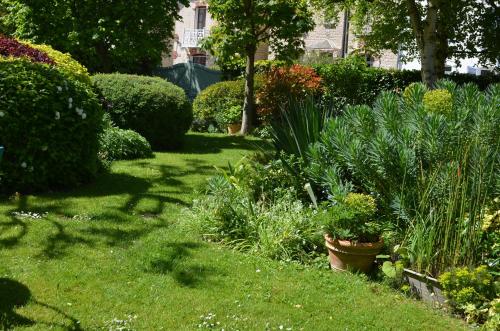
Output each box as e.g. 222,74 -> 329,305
325,234 -> 384,272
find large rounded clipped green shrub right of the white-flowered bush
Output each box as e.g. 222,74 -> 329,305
92,74 -> 193,149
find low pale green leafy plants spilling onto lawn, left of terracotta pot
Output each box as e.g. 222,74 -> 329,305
188,175 -> 322,262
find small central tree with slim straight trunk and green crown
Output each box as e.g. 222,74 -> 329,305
203,0 -> 314,134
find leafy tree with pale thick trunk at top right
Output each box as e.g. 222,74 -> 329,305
312,0 -> 500,86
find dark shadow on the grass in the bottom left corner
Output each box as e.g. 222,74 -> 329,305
0,278 -> 81,331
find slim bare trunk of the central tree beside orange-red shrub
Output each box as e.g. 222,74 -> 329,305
240,47 -> 257,135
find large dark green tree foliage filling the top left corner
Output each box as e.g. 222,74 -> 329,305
0,0 -> 189,73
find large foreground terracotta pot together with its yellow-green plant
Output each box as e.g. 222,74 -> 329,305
322,193 -> 384,272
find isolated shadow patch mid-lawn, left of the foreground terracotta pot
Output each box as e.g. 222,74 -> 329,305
147,242 -> 218,288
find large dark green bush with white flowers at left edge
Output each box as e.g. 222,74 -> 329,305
0,59 -> 102,191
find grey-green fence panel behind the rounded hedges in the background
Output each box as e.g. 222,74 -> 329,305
155,62 -> 222,101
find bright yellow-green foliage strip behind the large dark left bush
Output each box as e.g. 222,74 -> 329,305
23,42 -> 92,85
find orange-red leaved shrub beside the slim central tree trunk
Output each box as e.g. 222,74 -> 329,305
257,64 -> 321,117
